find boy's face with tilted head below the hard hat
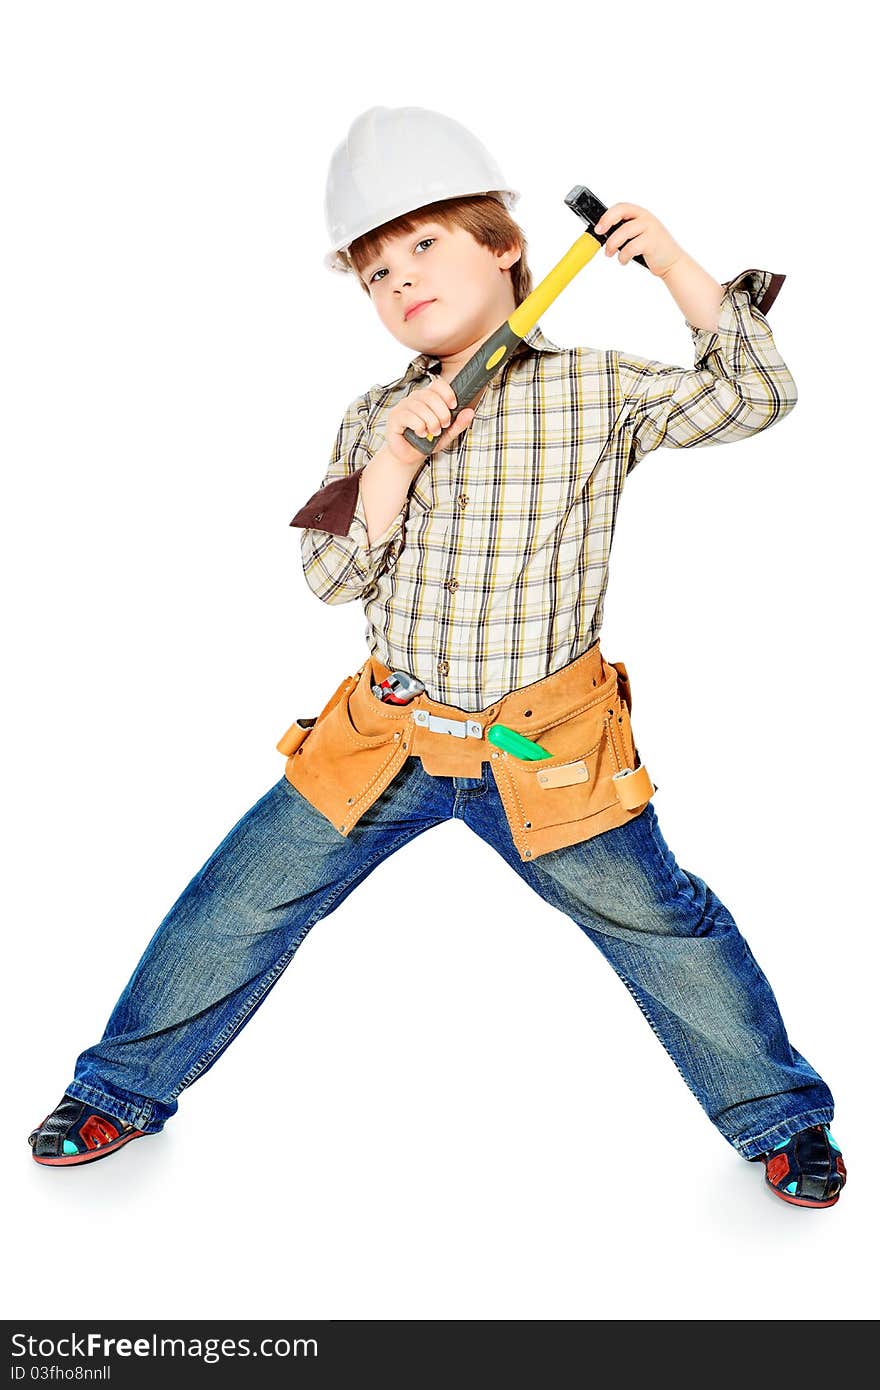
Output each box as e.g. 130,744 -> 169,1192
360,220 -> 520,357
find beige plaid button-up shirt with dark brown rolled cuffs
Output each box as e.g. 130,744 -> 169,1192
291,270 -> 798,713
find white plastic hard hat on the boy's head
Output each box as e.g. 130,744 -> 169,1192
324,106 -> 520,271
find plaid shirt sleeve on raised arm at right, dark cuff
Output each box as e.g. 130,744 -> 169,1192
614,270 -> 798,474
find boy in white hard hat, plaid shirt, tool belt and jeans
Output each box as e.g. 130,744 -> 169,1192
31,107 -> 847,1208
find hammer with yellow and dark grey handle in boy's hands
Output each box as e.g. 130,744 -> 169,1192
403,183 -> 651,455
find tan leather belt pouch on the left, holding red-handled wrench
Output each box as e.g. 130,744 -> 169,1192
277,662 -> 409,835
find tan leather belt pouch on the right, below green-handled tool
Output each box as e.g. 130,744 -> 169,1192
492,662 -> 656,859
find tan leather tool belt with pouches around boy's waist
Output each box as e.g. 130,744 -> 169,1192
277,642 -> 656,859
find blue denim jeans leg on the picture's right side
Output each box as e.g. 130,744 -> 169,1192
464,791 -> 834,1158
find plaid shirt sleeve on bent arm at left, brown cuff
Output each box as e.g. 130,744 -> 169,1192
291,396 -> 407,603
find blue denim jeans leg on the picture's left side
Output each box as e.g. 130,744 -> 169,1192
67,759 -> 452,1133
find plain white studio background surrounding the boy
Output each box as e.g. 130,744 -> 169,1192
0,0 -> 879,1319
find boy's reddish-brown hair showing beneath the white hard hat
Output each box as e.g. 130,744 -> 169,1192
348,193 -> 532,304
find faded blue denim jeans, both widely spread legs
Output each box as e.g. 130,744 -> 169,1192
68,758 -> 834,1158
